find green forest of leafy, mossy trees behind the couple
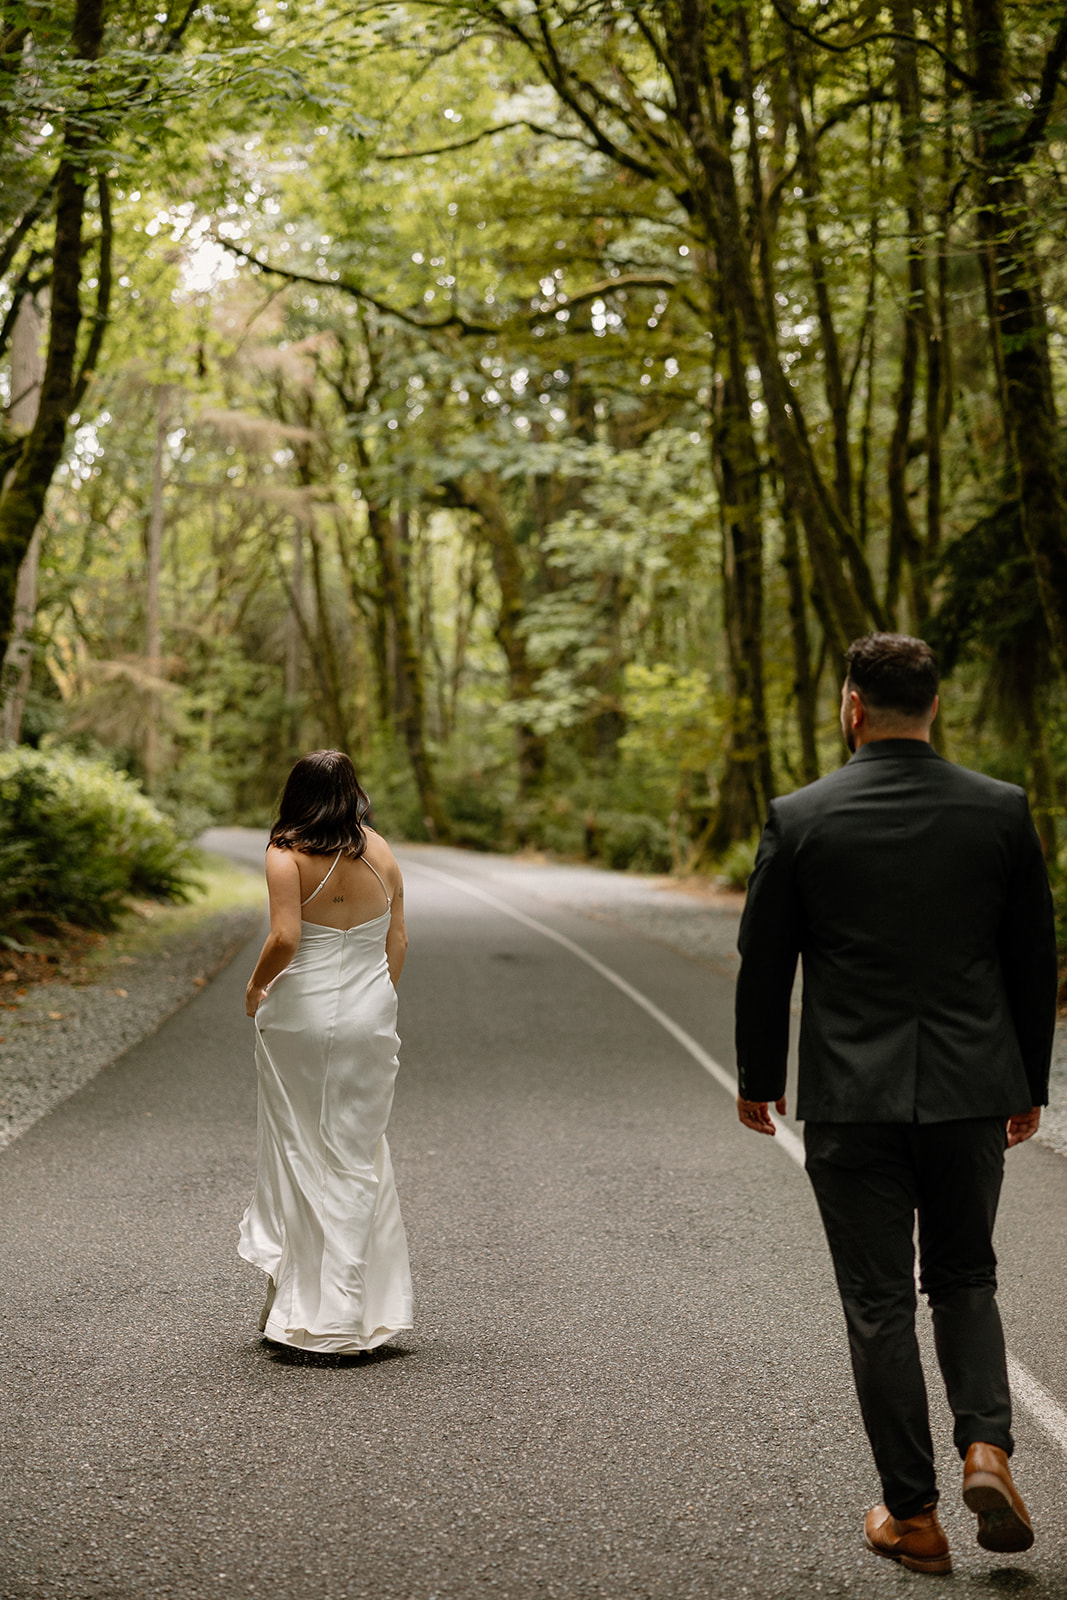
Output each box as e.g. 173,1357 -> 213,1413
0,0 -> 1067,882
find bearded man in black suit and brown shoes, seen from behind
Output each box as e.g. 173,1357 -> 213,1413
737,634 -> 1056,1573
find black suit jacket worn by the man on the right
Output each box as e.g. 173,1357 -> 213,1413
737,739 -> 1057,1122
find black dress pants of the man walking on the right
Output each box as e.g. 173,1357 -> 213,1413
805,1117 -> 1013,1517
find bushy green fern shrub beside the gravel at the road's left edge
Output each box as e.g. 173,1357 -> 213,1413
0,746 -> 194,928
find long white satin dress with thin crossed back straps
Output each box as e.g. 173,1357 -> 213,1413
238,854 -> 411,1354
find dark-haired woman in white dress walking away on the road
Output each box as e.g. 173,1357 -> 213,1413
240,750 -> 411,1354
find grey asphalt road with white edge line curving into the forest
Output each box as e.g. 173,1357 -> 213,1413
0,850 -> 1067,1600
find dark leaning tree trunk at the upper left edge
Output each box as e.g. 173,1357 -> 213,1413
0,0 -> 104,653
